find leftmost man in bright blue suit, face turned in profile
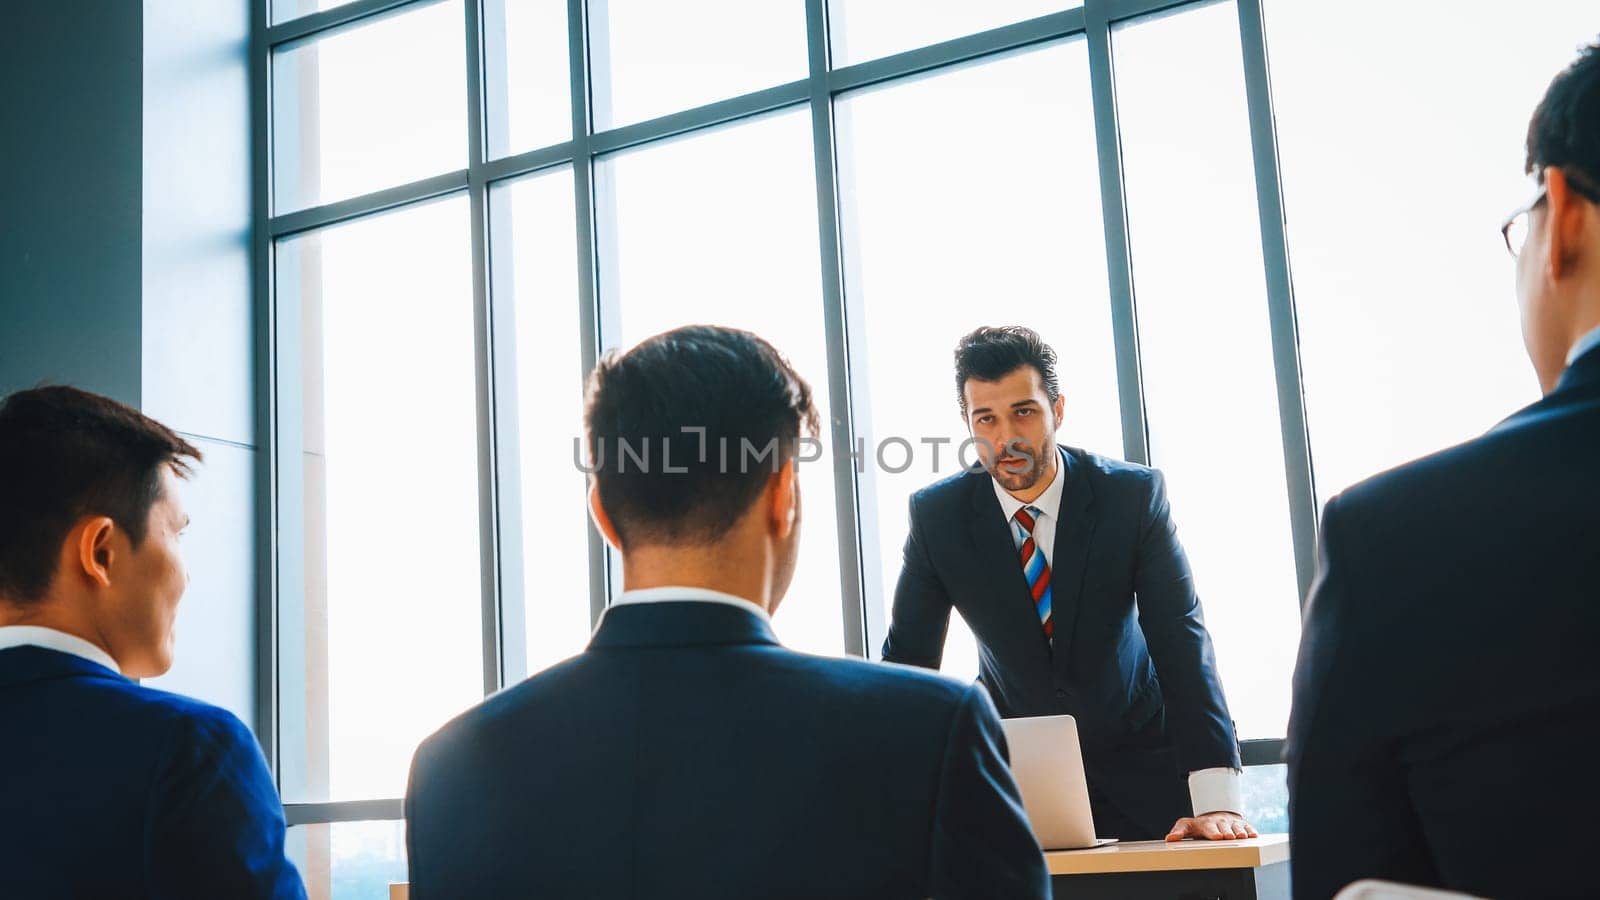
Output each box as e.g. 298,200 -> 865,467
0,381 -> 306,898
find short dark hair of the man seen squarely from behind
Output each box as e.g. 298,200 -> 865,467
584,325 -> 818,548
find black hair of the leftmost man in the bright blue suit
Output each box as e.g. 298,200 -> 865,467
0,386 -> 200,605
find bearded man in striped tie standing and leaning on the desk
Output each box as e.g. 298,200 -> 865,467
883,327 -> 1256,841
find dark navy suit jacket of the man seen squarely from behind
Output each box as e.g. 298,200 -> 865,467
406,602 -> 1050,900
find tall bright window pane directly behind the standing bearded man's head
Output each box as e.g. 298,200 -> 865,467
837,40 -> 1122,677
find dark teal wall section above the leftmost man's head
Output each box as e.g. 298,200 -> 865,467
0,0 -> 142,404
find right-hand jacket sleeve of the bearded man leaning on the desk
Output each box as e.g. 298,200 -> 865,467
1133,472 -> 1238,772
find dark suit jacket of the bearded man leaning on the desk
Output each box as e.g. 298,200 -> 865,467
883,447 -> 1238,839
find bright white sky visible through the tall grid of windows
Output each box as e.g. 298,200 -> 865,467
268,0 -> 1595,801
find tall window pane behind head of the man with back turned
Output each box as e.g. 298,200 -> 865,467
598,112 -> 845,653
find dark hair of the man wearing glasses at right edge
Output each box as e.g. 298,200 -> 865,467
1525,38 -> 1600,185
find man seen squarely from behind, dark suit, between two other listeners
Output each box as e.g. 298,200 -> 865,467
406,327 -> 1050,900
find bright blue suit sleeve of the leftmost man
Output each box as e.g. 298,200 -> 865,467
146,708 -> 306,900
